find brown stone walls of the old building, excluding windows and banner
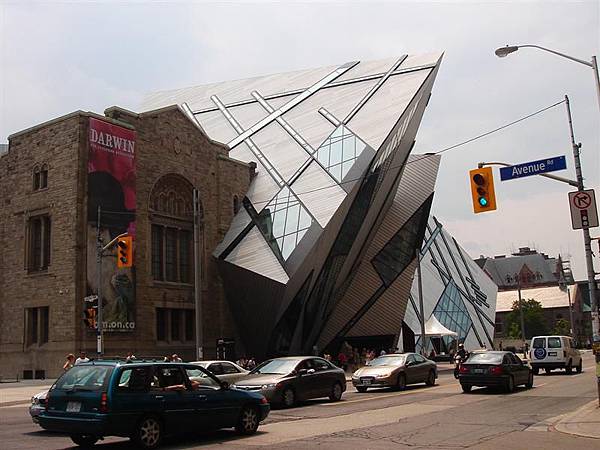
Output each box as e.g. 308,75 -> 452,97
0,106 -> 254,378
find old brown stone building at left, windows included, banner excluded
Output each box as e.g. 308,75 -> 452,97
0,106 -> 255,378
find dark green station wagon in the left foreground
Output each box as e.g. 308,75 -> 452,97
39,360 -> 270,449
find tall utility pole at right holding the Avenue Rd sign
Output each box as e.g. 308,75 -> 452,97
565,96 -> 600,406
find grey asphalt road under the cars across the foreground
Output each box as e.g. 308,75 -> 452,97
0,354 -> 600,450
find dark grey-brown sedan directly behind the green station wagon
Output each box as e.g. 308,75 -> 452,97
234,356 -> 346,408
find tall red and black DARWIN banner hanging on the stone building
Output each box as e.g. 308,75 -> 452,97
87,118 -> 136,332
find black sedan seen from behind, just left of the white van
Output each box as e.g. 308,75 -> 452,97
458,351 -> 533,392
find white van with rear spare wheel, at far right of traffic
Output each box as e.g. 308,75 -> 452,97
529,336 -> 582,375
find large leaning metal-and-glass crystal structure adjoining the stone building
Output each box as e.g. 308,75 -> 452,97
144,54 -> 441,358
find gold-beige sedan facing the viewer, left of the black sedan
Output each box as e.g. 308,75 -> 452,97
352,353 -> 437,392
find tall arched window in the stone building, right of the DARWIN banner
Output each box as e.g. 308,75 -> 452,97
149,175 -> 202,284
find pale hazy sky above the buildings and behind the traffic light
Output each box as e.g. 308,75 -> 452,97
0,0 -> 600,279
